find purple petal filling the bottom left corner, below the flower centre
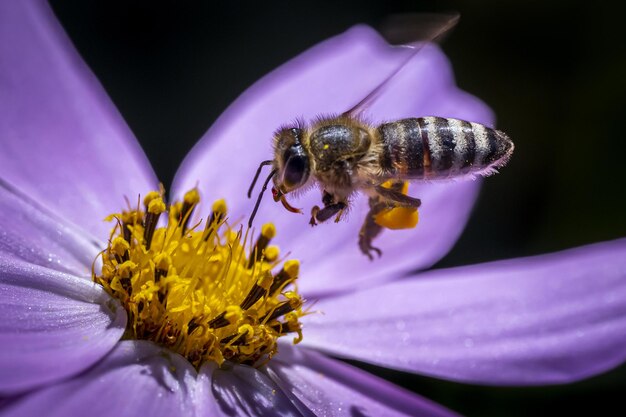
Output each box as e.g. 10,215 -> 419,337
3,341 -> 196,417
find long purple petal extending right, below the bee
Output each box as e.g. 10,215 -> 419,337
303,239 -> 626,385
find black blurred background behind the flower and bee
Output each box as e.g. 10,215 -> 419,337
52,0 -> 626,416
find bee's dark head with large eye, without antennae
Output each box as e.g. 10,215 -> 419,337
274,127 -> 311,194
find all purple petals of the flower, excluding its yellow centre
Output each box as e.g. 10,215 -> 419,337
0,1 -> 626,416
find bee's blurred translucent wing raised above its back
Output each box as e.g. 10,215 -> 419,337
343,13 -> 459,117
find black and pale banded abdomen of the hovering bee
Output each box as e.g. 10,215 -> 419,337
378,117 -> 513,179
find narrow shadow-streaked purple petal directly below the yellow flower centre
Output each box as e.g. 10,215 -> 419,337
205,364 -> 313,417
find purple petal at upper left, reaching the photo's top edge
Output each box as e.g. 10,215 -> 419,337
0,0 -> 157,239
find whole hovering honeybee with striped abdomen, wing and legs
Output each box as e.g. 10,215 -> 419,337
248,16 -> 514,259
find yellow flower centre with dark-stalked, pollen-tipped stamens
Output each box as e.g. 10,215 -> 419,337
92,189 -> 305,368
